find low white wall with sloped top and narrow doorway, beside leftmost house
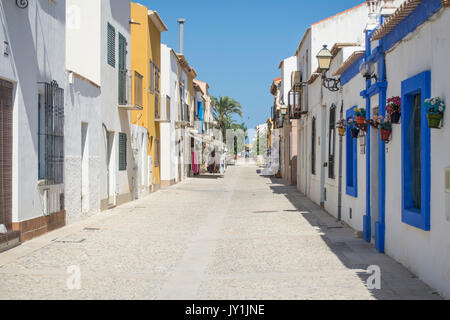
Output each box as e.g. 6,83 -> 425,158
64,73 -> 101,223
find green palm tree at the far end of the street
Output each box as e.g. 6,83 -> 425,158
211,96 -> 245,141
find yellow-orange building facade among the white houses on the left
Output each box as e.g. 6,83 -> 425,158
131,2 -> 167,191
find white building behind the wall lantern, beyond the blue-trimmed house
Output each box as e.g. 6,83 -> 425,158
295,4 -> 368,205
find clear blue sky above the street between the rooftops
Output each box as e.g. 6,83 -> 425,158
137,0 -> 364,129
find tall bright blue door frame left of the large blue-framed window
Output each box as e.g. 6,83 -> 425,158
361,31 -> 387,253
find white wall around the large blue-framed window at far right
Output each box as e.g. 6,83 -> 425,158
386,9 -> 450,297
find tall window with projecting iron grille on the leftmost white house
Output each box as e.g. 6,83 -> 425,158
38,81 -> 64,185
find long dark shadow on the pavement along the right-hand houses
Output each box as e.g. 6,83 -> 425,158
270,177 -> 441,300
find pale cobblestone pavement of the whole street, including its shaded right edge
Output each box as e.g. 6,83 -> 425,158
0,164 -> 440,300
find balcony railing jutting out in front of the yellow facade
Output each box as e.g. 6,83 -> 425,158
119,70 -> 144,110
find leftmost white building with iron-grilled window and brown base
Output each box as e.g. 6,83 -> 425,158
0,0 -> 66,245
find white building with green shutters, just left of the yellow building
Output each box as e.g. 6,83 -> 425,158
65,0 -> 143,220
